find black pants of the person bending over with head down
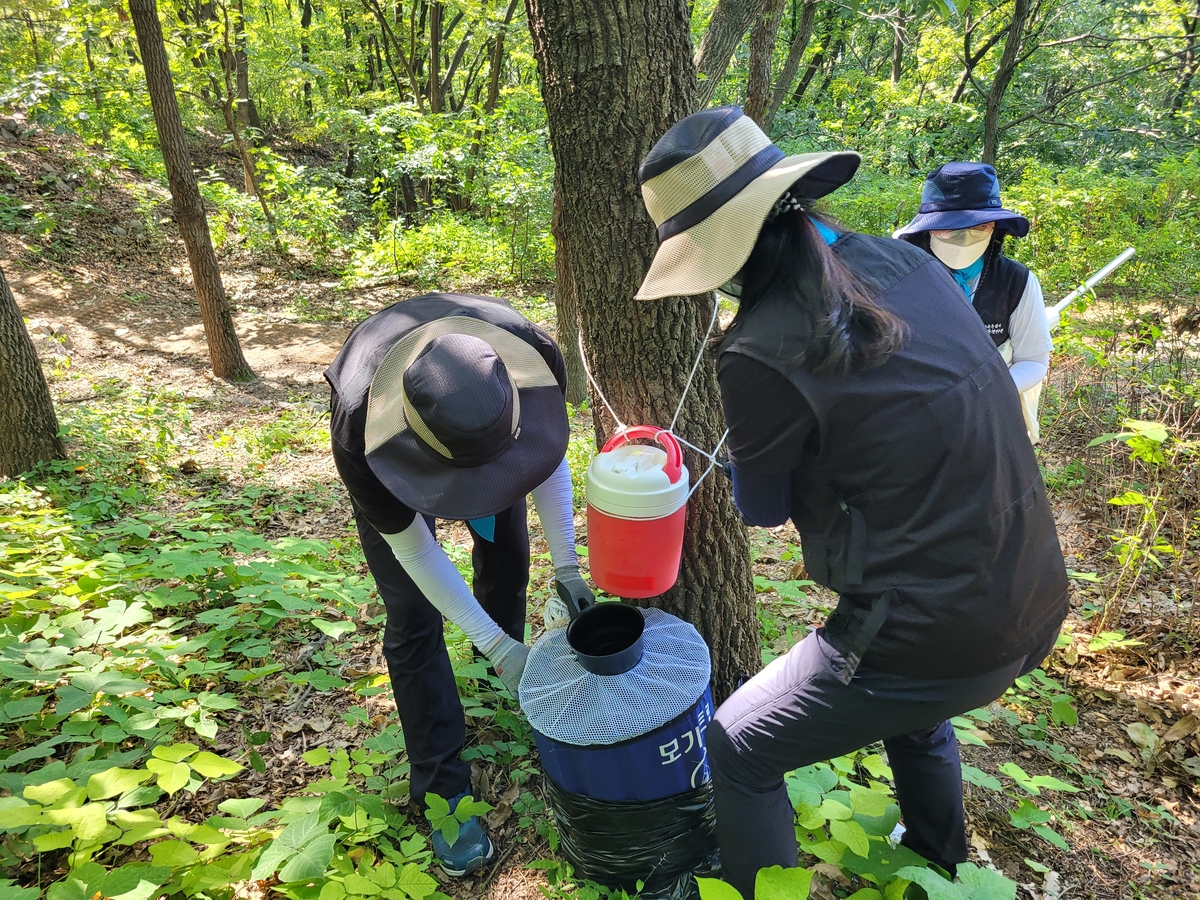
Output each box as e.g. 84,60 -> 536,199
358,499 -> 529,803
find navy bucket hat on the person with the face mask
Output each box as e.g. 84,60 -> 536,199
893,162 -> 1030,238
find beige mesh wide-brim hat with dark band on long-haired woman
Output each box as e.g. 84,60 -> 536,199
635,107 -> 862,300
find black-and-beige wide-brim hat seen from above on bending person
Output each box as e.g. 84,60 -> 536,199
365,313 -> 570,520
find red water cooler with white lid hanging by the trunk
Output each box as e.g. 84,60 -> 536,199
587,425 -> 688,599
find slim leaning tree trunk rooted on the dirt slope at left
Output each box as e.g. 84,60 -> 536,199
130,0 -> 254,382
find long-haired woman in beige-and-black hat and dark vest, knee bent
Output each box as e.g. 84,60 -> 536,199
637,107 -> 1067,900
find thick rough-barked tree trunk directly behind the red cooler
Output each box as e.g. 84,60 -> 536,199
526,0 -> 761,698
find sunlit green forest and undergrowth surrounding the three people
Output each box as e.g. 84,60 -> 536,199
0,0 -> 1200,900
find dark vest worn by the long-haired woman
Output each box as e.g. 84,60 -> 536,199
721,234 -> 1067,680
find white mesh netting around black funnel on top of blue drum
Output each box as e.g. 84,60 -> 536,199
520,608 -> 712,746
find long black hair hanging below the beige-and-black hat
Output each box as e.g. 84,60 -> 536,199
718,210 -> 907,374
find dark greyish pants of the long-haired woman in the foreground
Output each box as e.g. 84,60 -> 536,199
708,631 -> 1052,900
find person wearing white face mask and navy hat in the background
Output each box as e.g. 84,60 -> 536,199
892,162 -> 1051,442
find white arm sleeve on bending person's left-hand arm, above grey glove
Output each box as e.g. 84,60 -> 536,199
380,516 -> 504,655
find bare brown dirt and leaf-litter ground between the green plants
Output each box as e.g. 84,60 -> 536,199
0,136 -> 1200,900
